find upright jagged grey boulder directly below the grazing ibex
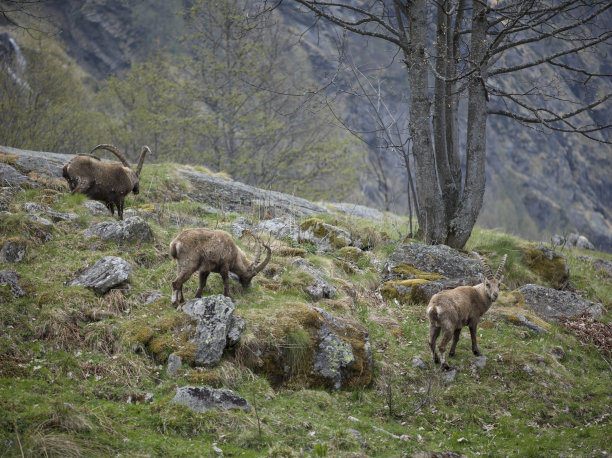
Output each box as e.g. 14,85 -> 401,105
182,294 -> 244,366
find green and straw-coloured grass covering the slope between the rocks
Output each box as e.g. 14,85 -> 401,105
0,165 -> 612,456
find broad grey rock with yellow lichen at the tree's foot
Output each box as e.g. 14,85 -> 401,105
383,243 -> 481,282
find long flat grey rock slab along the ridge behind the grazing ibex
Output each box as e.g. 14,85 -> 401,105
180,169 -> 327,217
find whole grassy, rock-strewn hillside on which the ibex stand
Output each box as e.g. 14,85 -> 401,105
0,147 -> 612,457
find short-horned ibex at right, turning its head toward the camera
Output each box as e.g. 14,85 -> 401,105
427,253 -> 508,369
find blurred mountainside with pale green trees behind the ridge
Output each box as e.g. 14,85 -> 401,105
0,0 -> 612,252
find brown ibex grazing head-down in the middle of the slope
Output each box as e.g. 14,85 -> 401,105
170,228 -> 272,306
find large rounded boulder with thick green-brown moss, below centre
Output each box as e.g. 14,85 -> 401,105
236,304 -> 373,389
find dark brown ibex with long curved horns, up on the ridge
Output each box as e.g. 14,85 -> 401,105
62,145 -> 151,219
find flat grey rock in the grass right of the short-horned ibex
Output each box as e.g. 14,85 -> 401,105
518,284 -> 605,319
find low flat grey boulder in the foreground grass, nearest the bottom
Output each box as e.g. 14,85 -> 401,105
172,386 -> 251,413
